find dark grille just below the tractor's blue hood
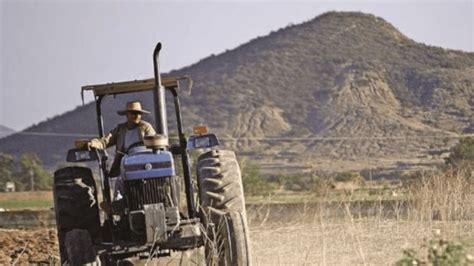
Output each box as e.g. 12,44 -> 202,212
125,177 -> 171,211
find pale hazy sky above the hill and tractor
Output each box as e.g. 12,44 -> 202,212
0,0 -> 474,130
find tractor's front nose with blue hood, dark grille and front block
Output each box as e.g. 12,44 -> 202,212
121,149 -> 179,242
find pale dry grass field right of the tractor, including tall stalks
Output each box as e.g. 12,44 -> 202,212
246,169 -> 474,265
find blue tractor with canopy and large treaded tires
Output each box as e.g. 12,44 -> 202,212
53,43 -> 251,265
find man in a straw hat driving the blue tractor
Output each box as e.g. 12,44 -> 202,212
87,101 -> 156,177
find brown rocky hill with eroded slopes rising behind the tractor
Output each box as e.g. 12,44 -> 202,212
0,12 -> 474,176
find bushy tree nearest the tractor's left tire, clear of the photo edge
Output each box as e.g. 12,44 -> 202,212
17,153 -> 53,190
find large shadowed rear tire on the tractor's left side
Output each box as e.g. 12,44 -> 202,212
53,166 -> 101,264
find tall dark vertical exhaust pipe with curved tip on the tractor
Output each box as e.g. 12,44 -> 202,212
153,42 -> 168,136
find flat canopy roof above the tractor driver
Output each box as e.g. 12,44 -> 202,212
81,76 -> 192,96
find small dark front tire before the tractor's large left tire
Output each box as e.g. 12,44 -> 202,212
64,229 -> 101,266
